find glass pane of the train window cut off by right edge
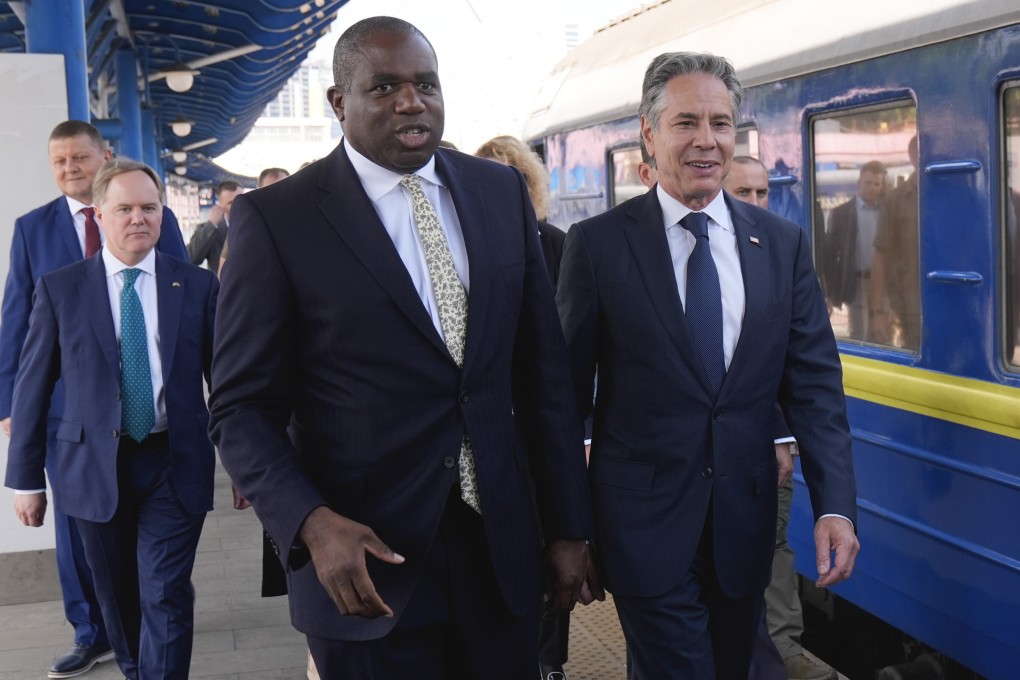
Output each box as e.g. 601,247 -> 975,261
1003,87 -> 1020,369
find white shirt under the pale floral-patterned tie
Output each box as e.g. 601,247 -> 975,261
344,138 -> 471,337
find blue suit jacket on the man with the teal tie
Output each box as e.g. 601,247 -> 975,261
6,253 -> 218,522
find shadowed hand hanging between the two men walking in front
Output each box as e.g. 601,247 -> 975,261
546,538 -> 606,616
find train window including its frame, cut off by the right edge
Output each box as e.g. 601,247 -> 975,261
998,80 -> 1020,373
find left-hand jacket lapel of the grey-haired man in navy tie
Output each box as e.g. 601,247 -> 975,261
624,191 -> 711,391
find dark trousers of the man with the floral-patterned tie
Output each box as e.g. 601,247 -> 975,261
306,485 -> 542,680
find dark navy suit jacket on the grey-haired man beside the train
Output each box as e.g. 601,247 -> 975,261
557,192 -> 856,597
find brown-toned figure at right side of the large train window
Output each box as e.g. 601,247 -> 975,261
868,135 -> 921,351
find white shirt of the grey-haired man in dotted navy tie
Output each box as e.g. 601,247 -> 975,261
656,185 -> 746,370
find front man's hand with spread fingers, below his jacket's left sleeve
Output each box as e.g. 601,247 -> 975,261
300,506 -> 404,619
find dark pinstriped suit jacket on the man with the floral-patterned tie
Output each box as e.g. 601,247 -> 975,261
211,144 -> 593,639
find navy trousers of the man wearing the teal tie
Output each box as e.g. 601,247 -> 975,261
77,433 -> 205,680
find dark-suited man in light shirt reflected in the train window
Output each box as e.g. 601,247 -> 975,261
820,160 -> 886,341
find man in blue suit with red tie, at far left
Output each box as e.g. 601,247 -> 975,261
0,120 -> 187,678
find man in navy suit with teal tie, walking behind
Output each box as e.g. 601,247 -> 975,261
6,159 -> 218,680
